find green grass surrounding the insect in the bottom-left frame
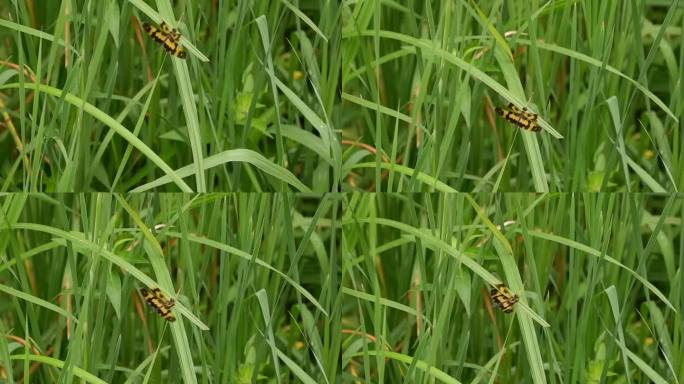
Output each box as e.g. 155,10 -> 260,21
0,194 -> 342,383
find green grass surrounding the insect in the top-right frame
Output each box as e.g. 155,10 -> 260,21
342,0 -> 684,192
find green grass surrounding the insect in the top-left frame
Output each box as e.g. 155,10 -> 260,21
0,0 -> 341,192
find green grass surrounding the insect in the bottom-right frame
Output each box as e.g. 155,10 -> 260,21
342,193 -> 684,383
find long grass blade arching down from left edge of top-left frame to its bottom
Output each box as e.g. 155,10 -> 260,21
0,83 -> 192,192
